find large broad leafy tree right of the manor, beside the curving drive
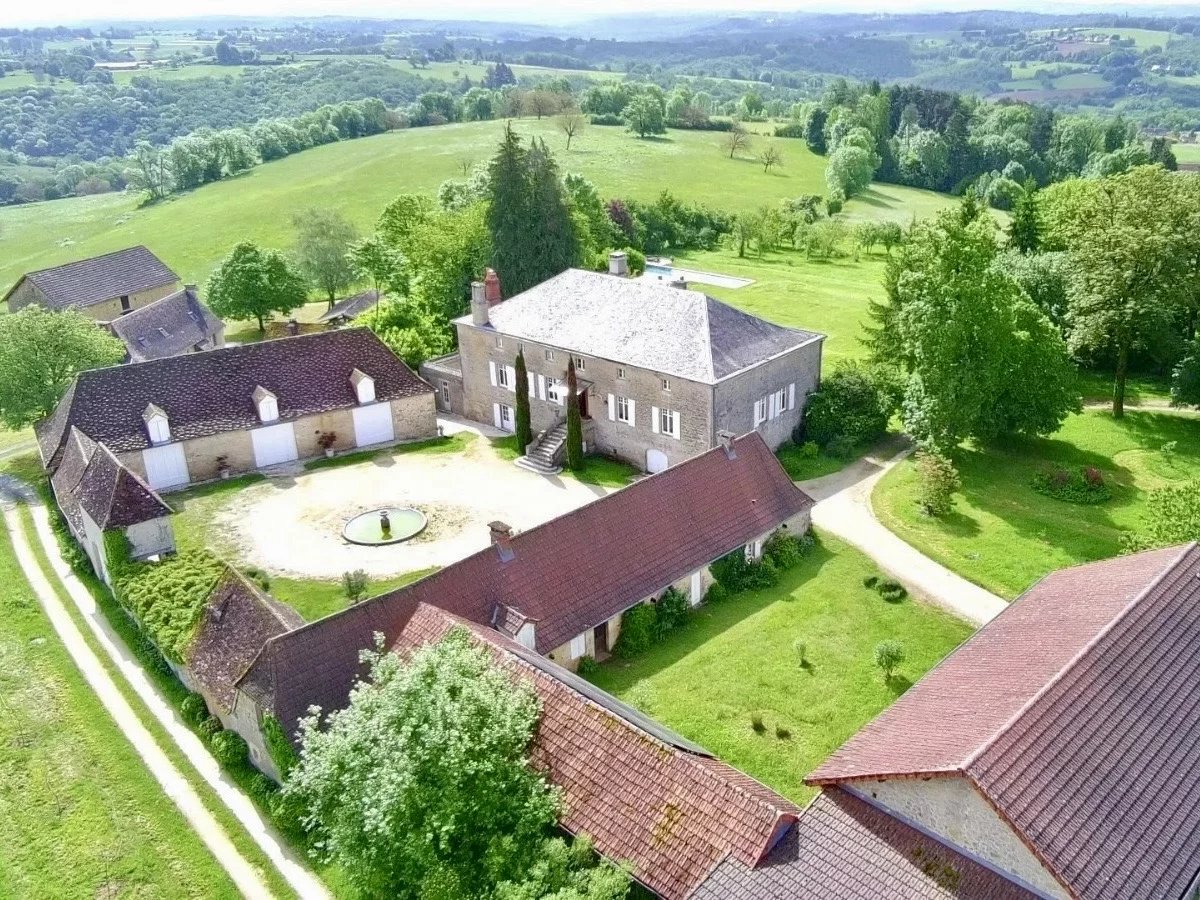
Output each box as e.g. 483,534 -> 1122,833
871,208 -> 1080,452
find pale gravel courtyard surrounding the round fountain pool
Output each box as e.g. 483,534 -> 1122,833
210,420 -> 612,578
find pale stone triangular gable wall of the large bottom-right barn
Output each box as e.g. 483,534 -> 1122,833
851,776 -> 1067,898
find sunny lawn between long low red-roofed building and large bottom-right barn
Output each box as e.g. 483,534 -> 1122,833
593,528 -> 972,803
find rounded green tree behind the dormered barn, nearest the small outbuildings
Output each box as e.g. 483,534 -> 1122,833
205,241 -> 308,331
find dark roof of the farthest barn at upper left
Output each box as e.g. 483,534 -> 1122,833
4,246 -> 179,310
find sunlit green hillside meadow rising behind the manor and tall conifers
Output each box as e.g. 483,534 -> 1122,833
0,119 -> 952,286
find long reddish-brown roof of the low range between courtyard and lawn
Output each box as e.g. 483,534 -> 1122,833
236,432 -> 812,748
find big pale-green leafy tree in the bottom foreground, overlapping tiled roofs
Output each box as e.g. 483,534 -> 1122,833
283,629 -> 559,900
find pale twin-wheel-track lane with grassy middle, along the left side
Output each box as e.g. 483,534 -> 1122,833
0,489 -> 330,900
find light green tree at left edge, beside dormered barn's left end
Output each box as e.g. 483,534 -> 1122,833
0,306 -> 125,431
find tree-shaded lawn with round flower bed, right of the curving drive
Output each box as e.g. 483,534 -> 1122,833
872,409 -> 1200,598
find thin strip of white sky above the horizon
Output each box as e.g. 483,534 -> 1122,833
14,0 -> 1196,26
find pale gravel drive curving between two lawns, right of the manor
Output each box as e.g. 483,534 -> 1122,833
798,443 -> 1008,625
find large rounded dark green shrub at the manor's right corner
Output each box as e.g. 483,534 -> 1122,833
804,365 -> 892,456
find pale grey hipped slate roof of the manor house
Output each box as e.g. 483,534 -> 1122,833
456,269 -> 824,384
